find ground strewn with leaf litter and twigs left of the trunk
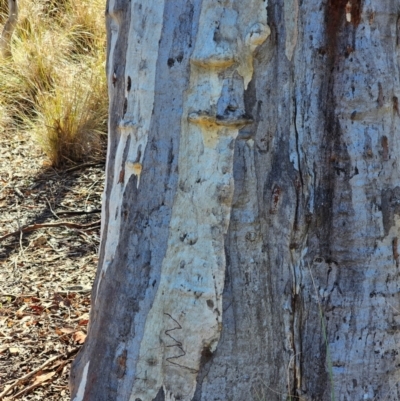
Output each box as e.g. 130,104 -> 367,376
0,133 -> 104,401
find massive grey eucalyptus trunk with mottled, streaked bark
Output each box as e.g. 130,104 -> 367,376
71,0 -> 400,401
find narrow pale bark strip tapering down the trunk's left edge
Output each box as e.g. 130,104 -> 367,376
97,0 -> 164,291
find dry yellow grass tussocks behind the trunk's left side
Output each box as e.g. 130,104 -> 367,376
0,0 -> 108,166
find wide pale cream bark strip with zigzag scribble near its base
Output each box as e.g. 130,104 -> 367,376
130,0 -> 270,401
